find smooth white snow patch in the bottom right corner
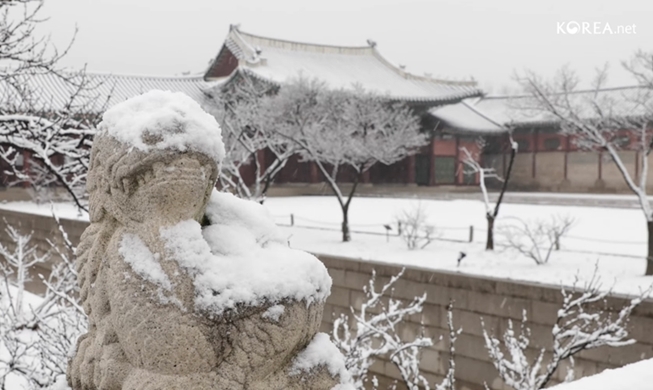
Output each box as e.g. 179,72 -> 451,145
551,359 -> 653,390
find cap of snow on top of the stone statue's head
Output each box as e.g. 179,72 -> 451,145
98,90 -> 225,163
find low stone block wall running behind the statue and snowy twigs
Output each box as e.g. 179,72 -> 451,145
0,209 -> 653,390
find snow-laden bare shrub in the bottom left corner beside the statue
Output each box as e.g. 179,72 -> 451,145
0,217 -> 87,389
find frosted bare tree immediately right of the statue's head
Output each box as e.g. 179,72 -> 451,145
205,78 -> 296,203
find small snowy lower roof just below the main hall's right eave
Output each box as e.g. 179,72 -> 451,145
429,99 -> 508,134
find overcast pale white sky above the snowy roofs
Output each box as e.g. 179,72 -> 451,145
43,0 -> 653,93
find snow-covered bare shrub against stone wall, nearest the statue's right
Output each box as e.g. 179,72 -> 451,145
332,270 -> 433,390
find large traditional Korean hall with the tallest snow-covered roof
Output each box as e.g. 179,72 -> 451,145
204,26 -> 482,189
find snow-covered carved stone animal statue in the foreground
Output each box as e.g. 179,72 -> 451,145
68,91 -> 350,390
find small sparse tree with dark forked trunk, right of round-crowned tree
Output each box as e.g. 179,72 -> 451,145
460,137 -> 518,250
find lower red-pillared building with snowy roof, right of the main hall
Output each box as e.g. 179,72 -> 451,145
430,87 -> 653,193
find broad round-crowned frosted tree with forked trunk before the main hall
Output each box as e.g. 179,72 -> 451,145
268,78 -> 427,241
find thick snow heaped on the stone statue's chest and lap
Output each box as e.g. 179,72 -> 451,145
161,190 -> 331,315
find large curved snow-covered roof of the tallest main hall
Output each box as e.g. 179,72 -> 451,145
206,27 -> 480,103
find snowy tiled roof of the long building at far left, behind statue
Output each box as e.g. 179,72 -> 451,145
0,73 -> 208,113
